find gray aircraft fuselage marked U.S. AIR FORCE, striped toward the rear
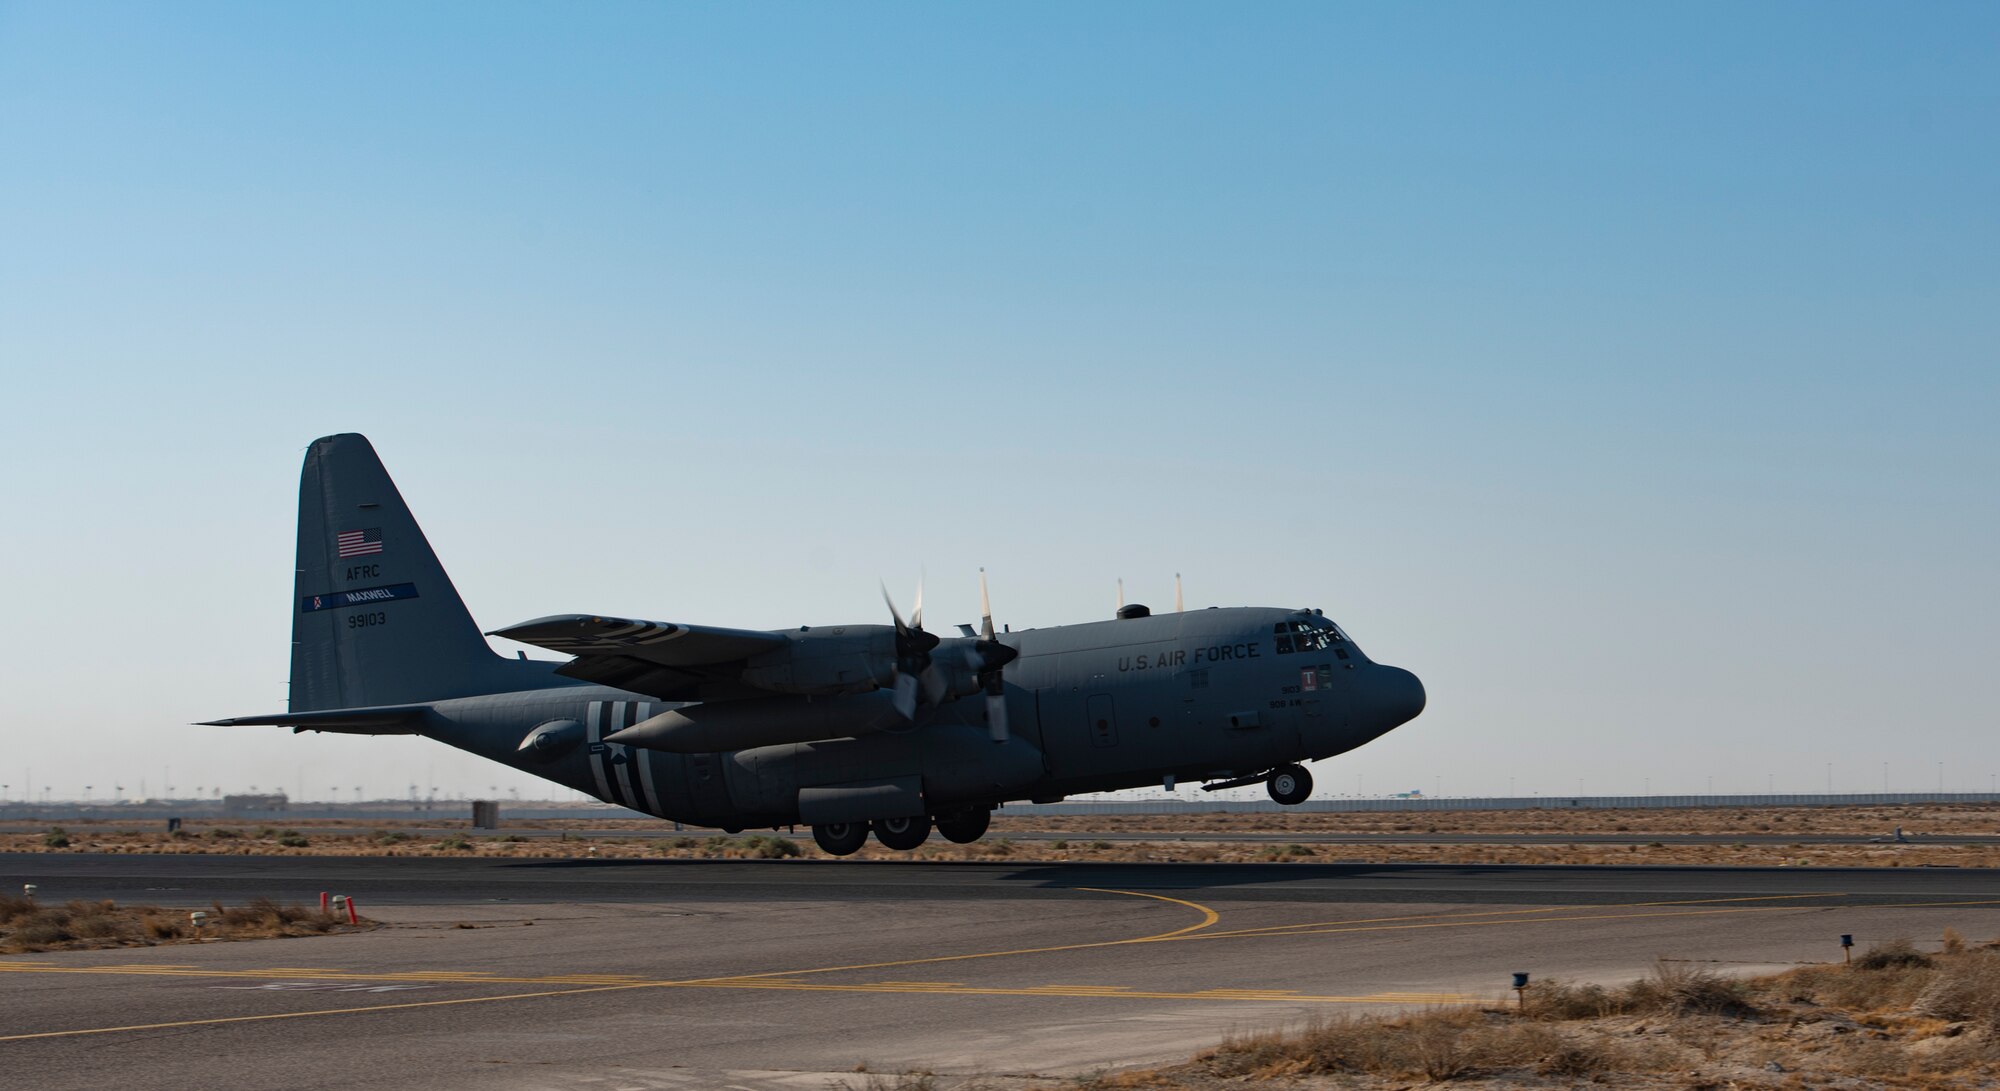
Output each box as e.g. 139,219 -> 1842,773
420,607 -> 1424,829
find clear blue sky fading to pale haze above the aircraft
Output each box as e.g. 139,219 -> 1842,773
0,4 -> 2000,795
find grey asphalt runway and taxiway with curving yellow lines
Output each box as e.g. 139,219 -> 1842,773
0,853 -> 2000,1089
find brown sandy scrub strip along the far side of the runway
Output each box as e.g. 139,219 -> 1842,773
0,805 -> 2000,867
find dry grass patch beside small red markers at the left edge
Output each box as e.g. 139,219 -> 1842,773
0,895 -> 344,955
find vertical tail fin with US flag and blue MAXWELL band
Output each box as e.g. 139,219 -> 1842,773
290,434 -> 570,713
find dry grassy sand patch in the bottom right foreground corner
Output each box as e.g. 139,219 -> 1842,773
1152,937 -> 2000,1091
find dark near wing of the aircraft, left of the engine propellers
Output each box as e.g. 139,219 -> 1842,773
488,613 -> 786,701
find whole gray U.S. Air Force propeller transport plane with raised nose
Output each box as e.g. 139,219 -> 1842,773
210,434 -> 1424,855
